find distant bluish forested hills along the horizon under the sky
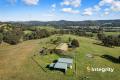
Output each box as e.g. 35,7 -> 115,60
3,19 -> 120,28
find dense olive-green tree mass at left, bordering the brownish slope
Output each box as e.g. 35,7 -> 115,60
0,25 -> 52,45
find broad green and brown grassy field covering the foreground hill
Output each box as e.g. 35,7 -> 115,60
0,35 -> 120,80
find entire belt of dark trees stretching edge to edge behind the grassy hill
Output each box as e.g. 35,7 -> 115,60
0,24 -> 120,47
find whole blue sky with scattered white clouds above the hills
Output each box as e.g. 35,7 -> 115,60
0,0 -> 120,21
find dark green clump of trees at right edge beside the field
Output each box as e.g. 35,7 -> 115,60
97,33 -> 120,47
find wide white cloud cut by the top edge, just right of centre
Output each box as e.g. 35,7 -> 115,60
61,0 -> 81,7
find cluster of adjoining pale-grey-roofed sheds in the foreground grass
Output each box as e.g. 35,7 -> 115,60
49,58 -> 73,72
